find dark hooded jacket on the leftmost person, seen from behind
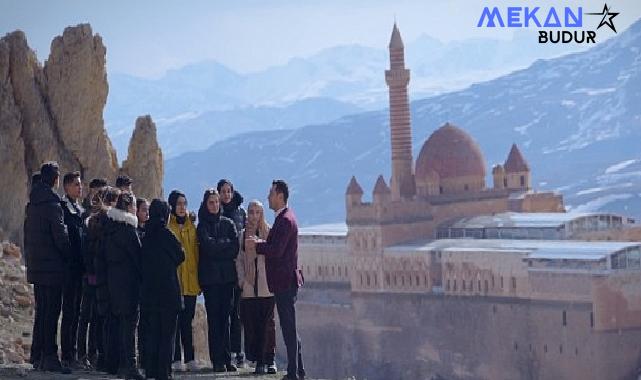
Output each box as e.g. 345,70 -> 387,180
24,182 -> 71,286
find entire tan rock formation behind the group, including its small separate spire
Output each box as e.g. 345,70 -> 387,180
0,24 -> 163,244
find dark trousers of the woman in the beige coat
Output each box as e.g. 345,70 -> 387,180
240,297 -> 276,365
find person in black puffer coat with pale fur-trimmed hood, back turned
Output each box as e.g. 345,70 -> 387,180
104,193 -> 143,380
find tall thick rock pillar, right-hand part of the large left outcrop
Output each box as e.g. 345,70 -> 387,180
44,24 -> 118,183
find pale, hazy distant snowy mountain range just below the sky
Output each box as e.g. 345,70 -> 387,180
105,34 -> 580,156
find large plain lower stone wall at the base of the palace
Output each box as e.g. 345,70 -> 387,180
298,289 -> 641,380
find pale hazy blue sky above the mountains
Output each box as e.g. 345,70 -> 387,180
0,0 -> 641,77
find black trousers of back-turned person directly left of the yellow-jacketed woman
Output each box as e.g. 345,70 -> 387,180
144,310 -> 178,380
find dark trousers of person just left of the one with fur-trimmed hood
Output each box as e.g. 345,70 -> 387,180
77,280 -> 103,359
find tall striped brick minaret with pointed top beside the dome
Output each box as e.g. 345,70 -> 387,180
385,23 -> 416,200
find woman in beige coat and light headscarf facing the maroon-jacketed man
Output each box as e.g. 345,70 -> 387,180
236,200 -> 276,374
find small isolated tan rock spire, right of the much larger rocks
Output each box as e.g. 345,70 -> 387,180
122,115 -> 163,200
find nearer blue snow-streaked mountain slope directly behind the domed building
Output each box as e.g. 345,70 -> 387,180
165,17 -> 641,224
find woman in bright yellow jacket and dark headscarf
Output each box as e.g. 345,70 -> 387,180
168,190 -> 200,371
